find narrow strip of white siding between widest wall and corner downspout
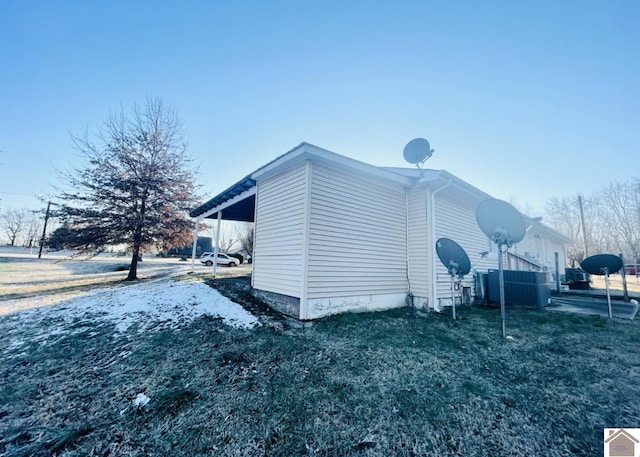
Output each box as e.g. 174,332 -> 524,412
407,188 -> 432,297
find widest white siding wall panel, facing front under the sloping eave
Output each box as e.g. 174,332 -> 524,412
307,163 -> 407,299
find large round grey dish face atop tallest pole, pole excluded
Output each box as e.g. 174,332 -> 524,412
476,199 -> 526,248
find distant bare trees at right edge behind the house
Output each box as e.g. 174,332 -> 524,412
544,178 -> 640,265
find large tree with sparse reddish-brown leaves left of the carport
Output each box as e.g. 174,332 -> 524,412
57,99 -> 198,280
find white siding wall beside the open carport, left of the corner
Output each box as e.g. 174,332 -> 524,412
253,163 -> 307,298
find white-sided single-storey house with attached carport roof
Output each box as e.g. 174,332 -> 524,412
191,143 -> 567,319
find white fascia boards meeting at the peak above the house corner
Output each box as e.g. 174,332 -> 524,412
251,143 -> 415,187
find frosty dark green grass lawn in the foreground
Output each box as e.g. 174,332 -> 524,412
0,268 -> 640,457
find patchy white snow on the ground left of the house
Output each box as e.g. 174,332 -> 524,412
0,279 -> 259,348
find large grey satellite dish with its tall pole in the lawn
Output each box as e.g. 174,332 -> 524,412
476,199 -> 527,338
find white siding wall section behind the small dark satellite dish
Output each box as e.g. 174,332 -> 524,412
432,194 -> 498,303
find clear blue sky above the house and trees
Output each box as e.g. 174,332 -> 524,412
0,0 -> 640,215
